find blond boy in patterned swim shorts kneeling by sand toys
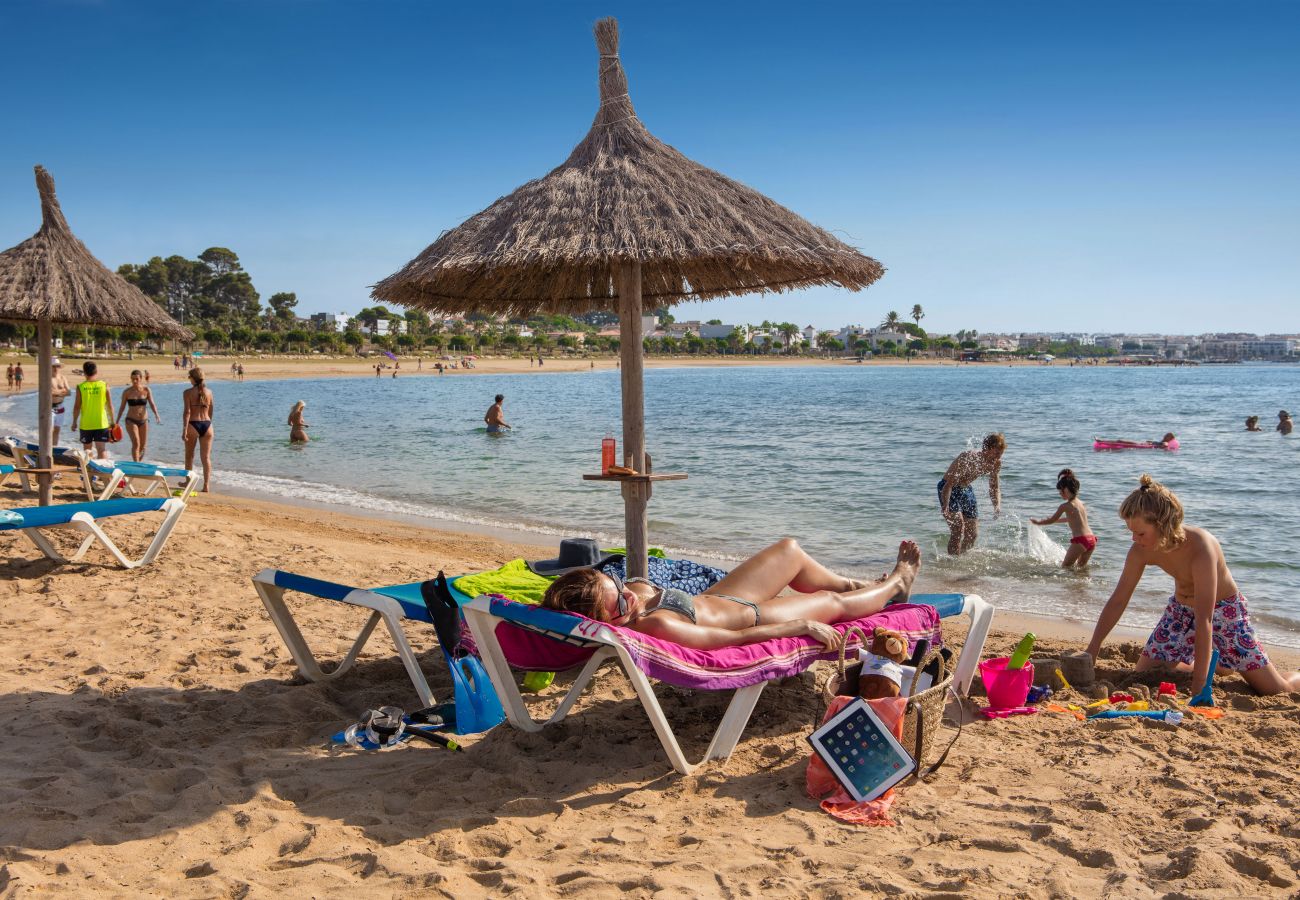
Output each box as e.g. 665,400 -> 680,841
1088,475 -> 1300,696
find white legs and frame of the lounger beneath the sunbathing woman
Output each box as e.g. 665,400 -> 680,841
462,594 -> 993,775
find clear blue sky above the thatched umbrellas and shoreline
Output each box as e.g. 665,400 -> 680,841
0,0 -> 1300,333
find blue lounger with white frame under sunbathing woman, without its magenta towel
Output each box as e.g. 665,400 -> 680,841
463,594 -> 993,775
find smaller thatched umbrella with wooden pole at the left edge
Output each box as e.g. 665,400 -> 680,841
0,165 -> 194,506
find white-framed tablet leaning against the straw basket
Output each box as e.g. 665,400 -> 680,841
809,697 -> 917,801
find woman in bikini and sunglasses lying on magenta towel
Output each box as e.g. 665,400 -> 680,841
542,537 -> 920,650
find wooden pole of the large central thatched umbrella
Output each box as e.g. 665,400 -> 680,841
616,263 -> 650,577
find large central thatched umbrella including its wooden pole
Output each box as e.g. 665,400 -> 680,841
373,18 -> 884,575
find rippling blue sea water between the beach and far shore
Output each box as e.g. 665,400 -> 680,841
0,363 -> 1300,648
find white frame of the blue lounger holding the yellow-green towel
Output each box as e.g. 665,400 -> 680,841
252,568 -> 437,706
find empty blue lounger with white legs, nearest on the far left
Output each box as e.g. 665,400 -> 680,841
0,497 -> 185,568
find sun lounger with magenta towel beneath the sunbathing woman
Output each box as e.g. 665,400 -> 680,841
464,594 -> 992,775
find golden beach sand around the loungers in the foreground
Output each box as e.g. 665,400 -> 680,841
0,489 -> 1300,897
